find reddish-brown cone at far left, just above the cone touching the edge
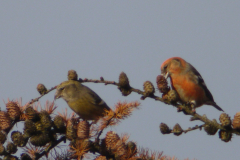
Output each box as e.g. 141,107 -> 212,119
6,101 -> 21,120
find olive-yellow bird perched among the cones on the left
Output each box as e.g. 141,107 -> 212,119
54,80 -> 110,120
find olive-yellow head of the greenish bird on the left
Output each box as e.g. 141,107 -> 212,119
54,80 -> 81,102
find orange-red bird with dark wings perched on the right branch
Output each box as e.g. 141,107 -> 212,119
161,57 -> 223,111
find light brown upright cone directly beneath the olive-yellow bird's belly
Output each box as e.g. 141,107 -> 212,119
77,121 -> 90,139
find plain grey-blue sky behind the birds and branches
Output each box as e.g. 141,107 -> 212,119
0,0 -> 240,160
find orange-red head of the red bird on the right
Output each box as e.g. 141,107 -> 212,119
161,57 -> 187,79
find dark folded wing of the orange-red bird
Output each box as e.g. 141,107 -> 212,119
189,64 -> 214,102
